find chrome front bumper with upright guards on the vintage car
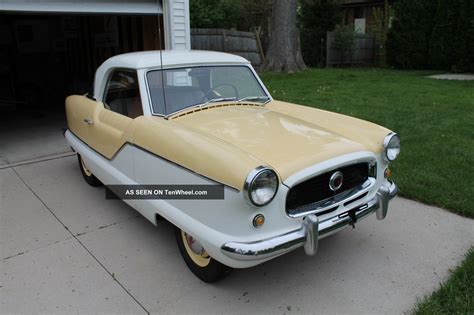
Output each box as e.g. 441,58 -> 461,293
221,183 -> 397,260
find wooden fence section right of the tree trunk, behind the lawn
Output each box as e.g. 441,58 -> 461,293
326,32 -> 376,67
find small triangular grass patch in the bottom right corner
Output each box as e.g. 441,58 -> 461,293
413,248 -> 474,315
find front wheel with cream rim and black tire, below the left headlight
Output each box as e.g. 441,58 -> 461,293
175,228 -> 231,282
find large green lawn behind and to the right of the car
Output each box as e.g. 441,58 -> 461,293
262,69 -> 474,218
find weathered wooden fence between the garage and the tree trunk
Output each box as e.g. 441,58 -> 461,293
191,28 -> 264,66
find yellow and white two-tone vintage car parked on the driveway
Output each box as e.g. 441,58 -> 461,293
65,51 -> 400,282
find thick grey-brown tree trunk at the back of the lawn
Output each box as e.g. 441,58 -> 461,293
262,0 -> 306,73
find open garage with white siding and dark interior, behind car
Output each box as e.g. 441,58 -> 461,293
0,0 -> 190,167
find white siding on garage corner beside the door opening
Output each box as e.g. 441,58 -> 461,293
163,0 -> 191,50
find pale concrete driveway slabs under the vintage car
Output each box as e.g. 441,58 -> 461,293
0,156 -> 474,314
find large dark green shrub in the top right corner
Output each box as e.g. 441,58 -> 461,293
387,0 -> 474,72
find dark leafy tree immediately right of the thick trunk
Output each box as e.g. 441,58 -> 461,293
299,0 -> 342,66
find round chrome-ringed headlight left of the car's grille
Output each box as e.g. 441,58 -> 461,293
244,166 -> 278,207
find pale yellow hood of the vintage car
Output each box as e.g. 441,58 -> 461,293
171,105 -> 370,180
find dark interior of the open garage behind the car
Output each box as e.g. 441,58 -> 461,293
0,12 -> 164,168
